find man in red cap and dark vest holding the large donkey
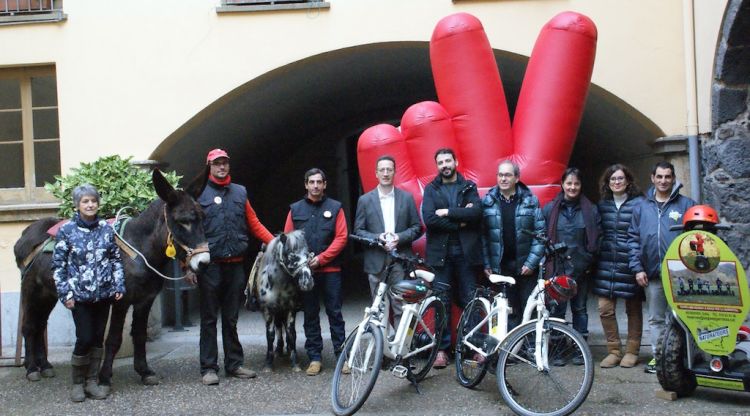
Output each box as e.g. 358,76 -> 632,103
198,149 -> 273,385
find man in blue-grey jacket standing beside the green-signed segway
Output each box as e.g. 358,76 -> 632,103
628,161 -> 695,373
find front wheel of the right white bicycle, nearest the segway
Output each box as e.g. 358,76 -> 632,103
497,321 -> 594,416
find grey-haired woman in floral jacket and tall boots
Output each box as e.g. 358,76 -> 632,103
52,184 -> 125,402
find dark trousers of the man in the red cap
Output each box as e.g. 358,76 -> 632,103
198,263 -> 247,374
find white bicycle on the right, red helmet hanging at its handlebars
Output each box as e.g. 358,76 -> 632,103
455,235 -> 594,416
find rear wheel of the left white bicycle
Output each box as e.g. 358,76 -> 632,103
409,298 -> 445,381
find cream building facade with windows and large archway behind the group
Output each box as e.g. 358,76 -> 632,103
0,0 -> 748,346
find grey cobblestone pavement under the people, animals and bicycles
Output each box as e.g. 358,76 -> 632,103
0,302 -> 750,416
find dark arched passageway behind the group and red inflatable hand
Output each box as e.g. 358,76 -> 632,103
152,42 -> 664,296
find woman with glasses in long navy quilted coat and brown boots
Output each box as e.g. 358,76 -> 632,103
593,164 -> 648,368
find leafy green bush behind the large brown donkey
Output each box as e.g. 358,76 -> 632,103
44,155 -> 180,218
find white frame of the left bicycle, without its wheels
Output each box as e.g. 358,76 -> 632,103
348,282 -> 440,367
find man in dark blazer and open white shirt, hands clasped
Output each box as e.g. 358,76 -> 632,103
354,156 -> 422,322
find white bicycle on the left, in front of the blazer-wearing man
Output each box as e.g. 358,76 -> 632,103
331,235 -> 447,415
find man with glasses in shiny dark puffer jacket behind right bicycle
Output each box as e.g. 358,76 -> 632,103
482,160 -> 545,330
